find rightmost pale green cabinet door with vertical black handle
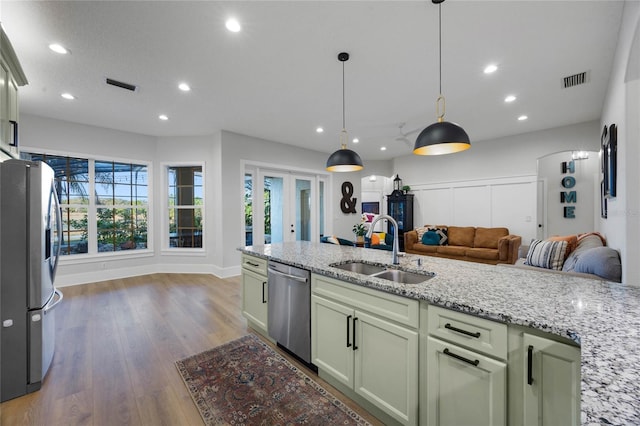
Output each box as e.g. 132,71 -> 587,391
523,333 -> 580,425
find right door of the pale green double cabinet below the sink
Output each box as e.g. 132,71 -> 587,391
354,310 -> 418,424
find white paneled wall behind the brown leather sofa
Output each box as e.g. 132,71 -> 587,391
394,121 -> 600,246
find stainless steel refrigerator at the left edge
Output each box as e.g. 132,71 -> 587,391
0,160 -> 62,401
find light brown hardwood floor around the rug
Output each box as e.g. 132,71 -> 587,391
0,274 -> 380,426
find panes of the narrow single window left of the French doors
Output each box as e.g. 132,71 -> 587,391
167,166 -> 204,248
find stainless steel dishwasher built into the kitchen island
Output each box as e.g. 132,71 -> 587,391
267,261 -> 311,364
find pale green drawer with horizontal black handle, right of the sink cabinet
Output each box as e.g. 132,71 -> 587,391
428,306 -> 507,359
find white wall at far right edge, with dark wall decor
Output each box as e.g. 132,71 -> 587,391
600,1 -> 640,286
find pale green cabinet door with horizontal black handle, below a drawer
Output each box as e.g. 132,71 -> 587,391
426,337 -> 507,426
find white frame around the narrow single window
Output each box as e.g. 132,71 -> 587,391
160,161 -> 207,251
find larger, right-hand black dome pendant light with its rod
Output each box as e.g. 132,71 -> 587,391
413,0 -> 471,155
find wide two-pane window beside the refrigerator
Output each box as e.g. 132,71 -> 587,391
21,152 -> 149,255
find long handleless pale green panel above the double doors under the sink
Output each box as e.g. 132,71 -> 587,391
311,274 -> 420,328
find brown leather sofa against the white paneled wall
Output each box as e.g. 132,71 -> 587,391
404,225 -> 522,265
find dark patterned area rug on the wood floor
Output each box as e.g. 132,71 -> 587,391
176,335 -> 369,425
